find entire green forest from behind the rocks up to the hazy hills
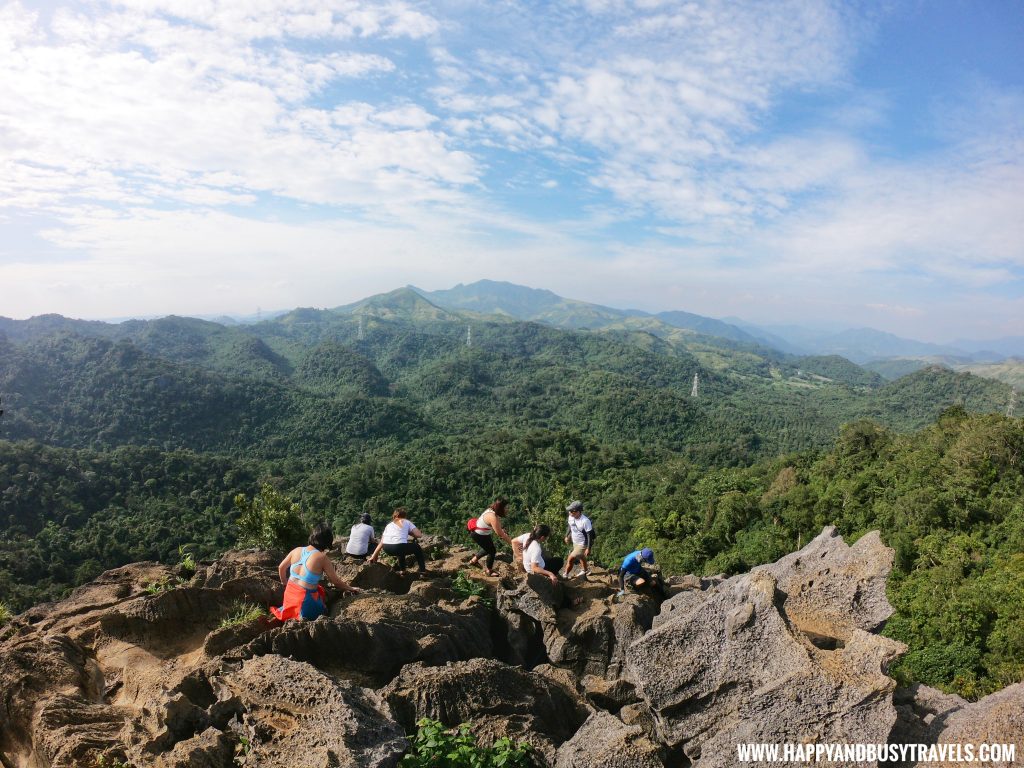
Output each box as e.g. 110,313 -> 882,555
0,291 -> 1024,696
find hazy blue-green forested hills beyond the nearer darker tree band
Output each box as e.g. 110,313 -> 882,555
0,307 -> 1010,462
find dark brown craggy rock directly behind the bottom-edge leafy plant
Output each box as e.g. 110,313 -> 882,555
380,658 -> 591,762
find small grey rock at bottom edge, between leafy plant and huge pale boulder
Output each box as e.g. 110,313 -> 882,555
555,712 -> 666,768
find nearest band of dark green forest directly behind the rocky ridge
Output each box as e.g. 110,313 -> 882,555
0,409 -> 1024,697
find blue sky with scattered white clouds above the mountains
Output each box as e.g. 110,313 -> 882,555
0,0 -> 1024,342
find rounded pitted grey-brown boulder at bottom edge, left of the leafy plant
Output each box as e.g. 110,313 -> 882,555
221,656 -> 409,768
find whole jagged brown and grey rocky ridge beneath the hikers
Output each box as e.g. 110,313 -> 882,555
0,528 -> 1024,768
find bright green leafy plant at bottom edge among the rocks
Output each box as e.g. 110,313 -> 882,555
399,718 -> 536,768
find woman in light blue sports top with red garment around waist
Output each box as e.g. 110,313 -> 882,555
270,522 -> 362,622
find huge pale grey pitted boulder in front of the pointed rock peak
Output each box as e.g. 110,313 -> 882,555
628,570 -> 904,768
